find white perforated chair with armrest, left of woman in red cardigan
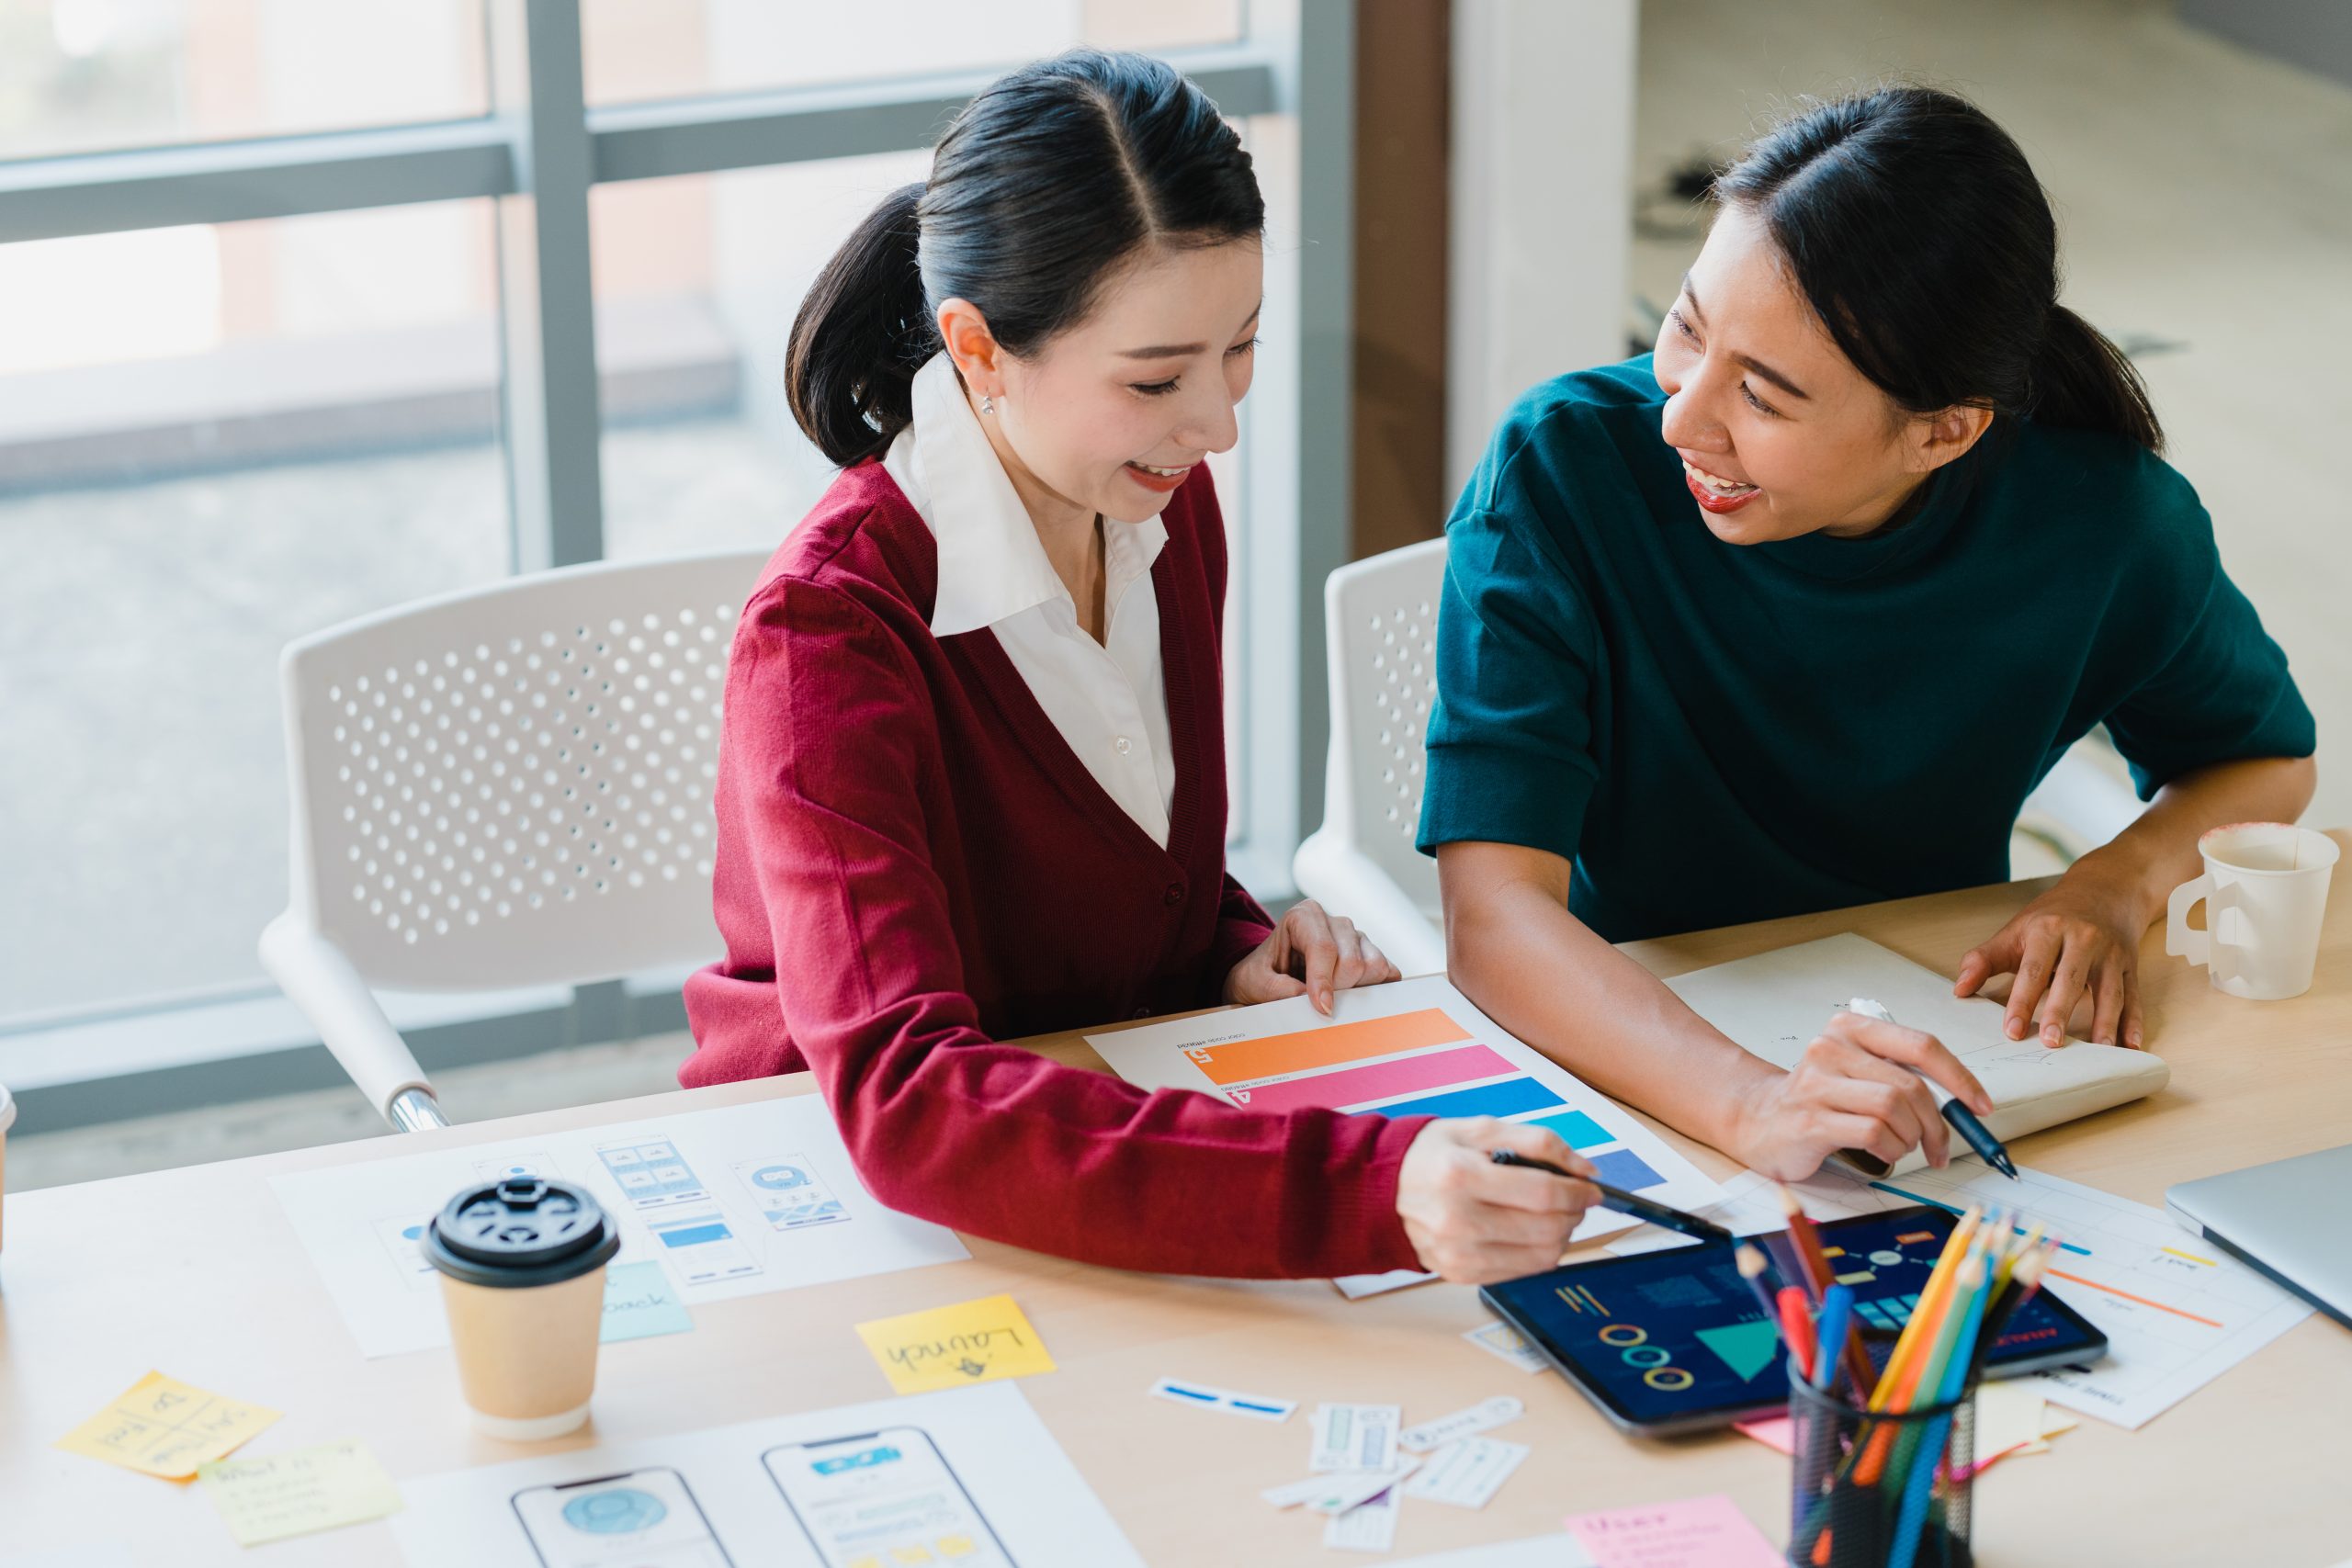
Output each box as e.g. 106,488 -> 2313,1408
261,550 -> 767,1131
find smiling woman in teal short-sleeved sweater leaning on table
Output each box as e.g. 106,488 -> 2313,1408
1420,87 -> 2314,1178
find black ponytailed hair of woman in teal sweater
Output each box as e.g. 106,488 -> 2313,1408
1714,85 -> 2164,451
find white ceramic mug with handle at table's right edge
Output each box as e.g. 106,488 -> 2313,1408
2164,823 -> 2338,1001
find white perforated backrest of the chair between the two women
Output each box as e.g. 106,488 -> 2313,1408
1324,538 -> 1446,915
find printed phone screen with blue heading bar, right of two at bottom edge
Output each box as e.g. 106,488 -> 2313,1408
760,1427 -> 1013,1568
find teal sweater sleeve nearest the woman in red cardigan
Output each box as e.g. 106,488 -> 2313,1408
1419,501 -> 1601,858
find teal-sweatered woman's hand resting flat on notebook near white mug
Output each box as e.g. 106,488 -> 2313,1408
1952,858 -> 2154,1051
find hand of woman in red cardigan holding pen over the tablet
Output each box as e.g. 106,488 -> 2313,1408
1397,1117 -> 1600,1286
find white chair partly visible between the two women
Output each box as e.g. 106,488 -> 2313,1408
1291,538 -> 1446,976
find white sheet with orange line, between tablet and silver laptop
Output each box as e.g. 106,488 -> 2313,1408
1606,1159 -> 2312,1429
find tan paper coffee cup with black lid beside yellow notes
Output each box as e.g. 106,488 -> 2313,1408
424,1176 -> 621,1443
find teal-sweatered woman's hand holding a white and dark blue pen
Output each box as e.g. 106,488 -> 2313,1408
1724,1013 -> 1992,1182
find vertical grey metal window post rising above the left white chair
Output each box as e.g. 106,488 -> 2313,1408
489,0 -> 605,571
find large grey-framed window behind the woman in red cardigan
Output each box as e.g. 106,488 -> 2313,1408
0,0 -> 1348,1077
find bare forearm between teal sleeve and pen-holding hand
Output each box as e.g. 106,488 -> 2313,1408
1440,844 -> 1781,1149
